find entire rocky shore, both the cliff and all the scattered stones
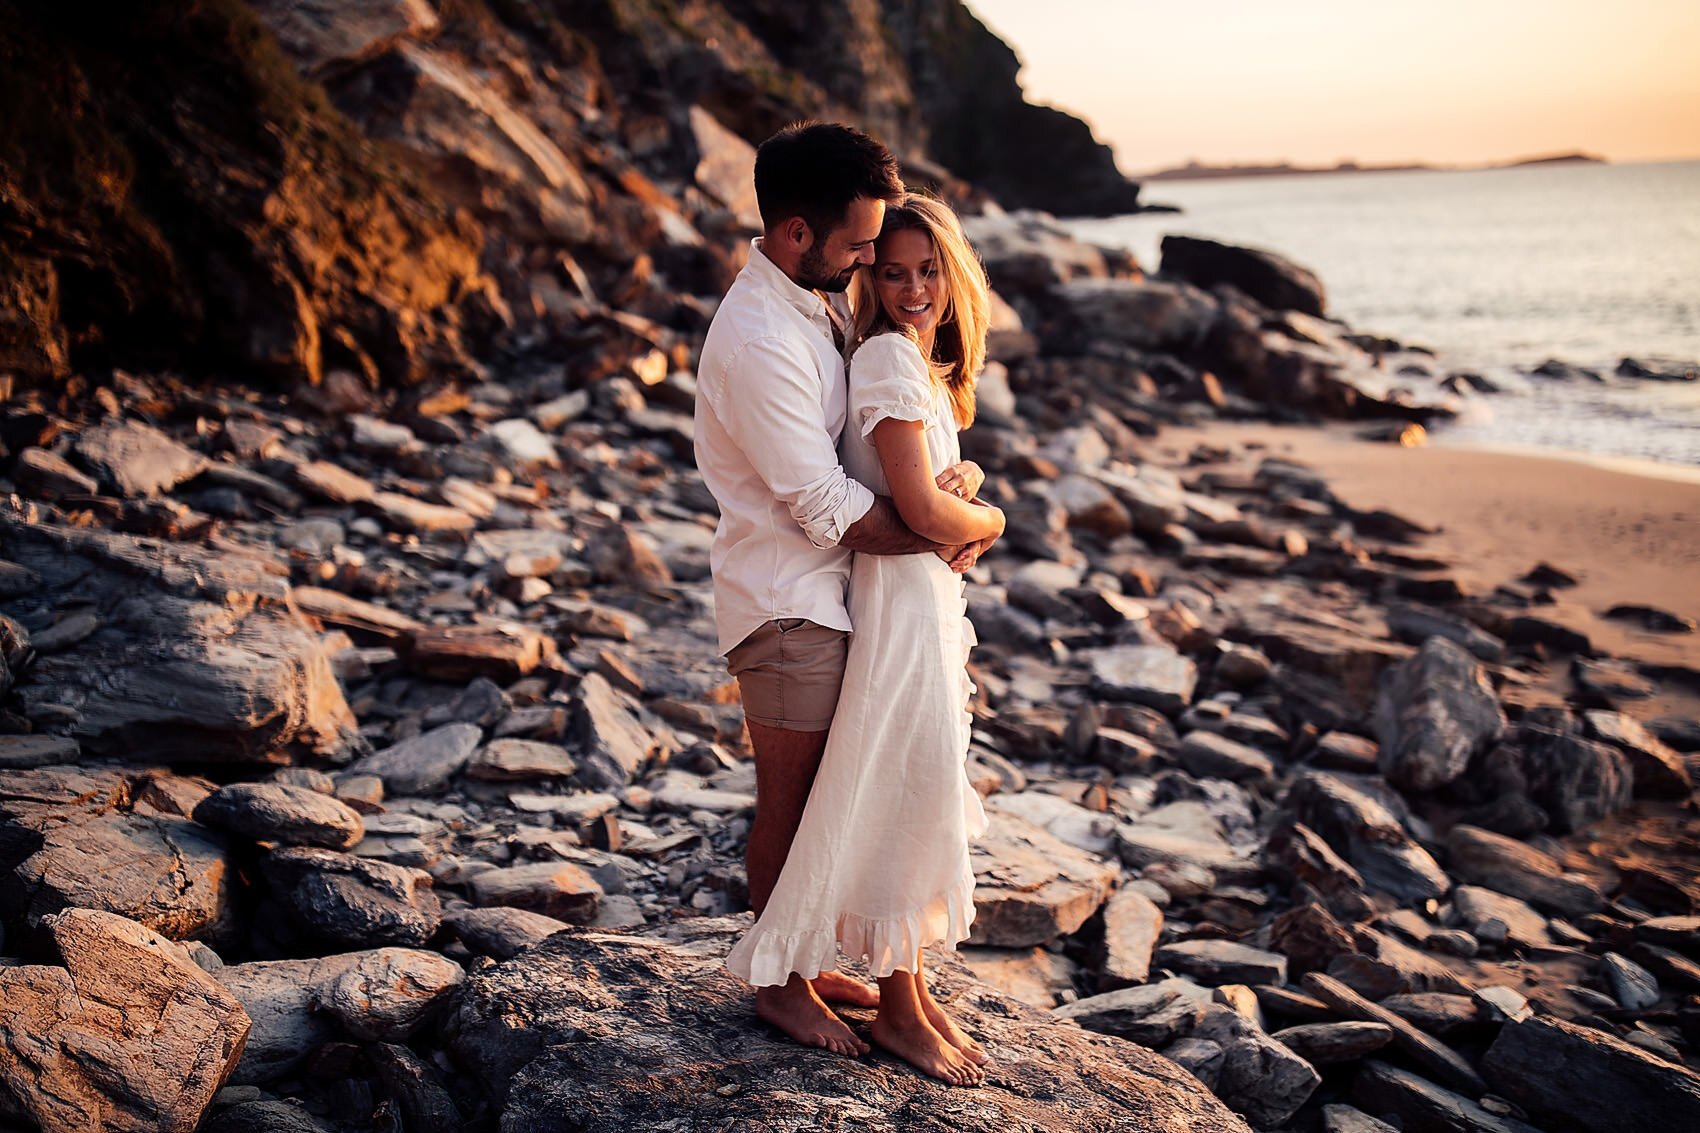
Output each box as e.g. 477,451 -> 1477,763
0,0 -> 1700,1133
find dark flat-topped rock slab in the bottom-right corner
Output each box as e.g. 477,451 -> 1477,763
1482,1016 -> 1700,1133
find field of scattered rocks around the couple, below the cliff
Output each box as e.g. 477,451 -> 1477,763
0,198 -> 1700,1131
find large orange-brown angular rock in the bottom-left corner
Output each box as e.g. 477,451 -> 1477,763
0,908 -> 250,1133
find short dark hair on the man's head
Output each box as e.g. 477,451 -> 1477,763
755,122 -> 903,240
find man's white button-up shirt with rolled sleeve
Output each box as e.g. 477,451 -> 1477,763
695,240 -> 874,653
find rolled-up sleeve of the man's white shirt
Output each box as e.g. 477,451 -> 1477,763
714,337 -> 874,549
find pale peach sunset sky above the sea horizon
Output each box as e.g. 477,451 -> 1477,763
966,0 -> 1700,174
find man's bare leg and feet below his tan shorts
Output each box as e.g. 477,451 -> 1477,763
745,720 -> 879,1055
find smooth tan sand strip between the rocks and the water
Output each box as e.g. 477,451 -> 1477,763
1159,416 -> 1700,669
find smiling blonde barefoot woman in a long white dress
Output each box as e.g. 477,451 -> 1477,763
728,194 -> 1003,1085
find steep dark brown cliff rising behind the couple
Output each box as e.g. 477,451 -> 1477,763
0,0 -> 1137,384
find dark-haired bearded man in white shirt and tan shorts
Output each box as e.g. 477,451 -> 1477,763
695,122 -> 972,1055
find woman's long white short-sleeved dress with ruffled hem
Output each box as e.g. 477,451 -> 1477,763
726,333 -> 986,987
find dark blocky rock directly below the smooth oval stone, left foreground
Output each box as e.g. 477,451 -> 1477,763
260,847 -> 442,948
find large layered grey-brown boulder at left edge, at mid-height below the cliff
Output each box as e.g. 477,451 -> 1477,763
0,515 -> 362,764
